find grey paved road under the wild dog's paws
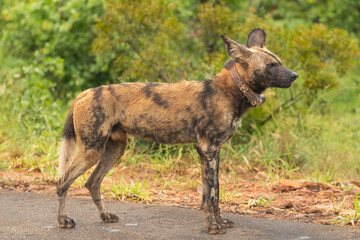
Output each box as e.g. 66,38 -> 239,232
0,190 -> 360,240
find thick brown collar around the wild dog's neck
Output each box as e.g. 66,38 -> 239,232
224,59 -> 265,107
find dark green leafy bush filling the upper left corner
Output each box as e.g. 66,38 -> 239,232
0,0 -> 108,98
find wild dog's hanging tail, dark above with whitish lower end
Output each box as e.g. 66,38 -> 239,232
58,106 -> 76,182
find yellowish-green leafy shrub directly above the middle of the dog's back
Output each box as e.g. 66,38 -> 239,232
93,0 -> 187,82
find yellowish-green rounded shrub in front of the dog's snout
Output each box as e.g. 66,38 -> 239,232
287,24 -> 360,103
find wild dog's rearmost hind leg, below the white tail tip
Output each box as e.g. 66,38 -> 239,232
57,147 -> 102,228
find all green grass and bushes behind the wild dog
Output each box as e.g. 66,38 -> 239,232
0,0 -> 360,182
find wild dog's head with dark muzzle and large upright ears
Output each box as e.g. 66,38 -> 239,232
221,28 -> 298,89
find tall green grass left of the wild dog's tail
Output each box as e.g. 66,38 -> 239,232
0,73 -> 67,181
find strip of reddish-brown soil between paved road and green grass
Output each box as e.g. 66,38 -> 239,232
0,169 -> 360,224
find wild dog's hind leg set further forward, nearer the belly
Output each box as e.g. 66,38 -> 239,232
85,128 -> 127,223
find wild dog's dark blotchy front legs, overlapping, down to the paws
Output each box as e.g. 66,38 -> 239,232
196,146 -> 234,234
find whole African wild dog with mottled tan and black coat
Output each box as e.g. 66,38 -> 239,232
57,29 -> 298,234
